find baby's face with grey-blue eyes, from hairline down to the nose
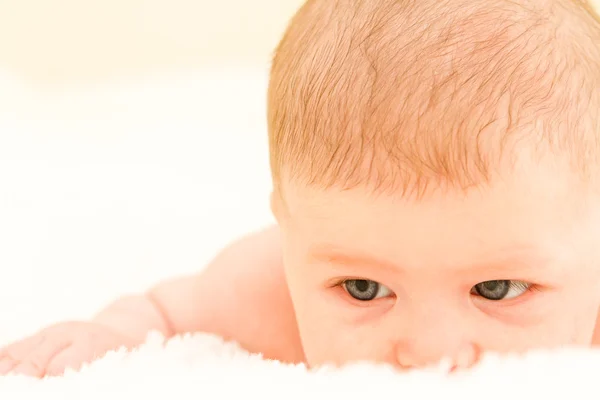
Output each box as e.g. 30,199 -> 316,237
274,157 -> 600,368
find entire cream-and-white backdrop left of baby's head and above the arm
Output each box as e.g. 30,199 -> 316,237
0,0 -> 596,343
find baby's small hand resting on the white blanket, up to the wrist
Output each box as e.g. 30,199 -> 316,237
0,322 -> 136,378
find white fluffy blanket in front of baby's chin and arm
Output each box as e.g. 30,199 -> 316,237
0,334 -> 600,400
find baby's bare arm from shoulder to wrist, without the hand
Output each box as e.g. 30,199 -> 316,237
94,227 -> 303,362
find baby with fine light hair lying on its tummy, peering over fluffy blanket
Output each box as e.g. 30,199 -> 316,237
0,0 -> 600,377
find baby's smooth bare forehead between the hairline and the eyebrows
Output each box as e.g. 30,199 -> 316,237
283,153 -> 600,266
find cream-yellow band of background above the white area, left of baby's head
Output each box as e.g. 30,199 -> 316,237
0,0 -> 302,85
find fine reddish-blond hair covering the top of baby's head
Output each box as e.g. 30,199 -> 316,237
268,0 -> 600,198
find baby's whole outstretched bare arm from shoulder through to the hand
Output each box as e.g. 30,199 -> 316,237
0,227 -> 304,377
